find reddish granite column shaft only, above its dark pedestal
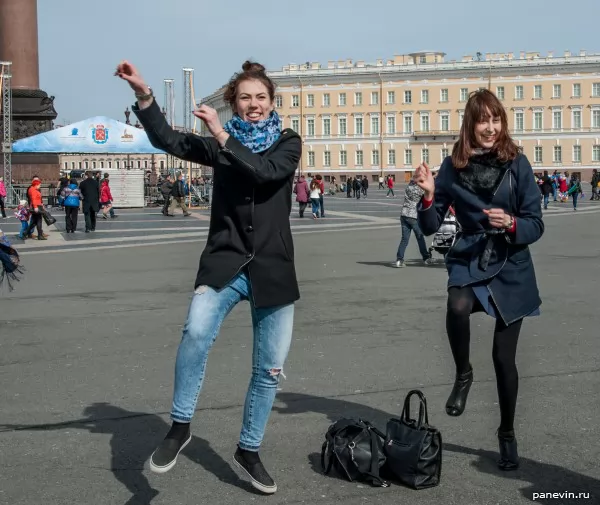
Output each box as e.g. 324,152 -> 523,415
0,0 -> 40,89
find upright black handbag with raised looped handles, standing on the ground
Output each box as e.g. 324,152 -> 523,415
384,390 -> 442,489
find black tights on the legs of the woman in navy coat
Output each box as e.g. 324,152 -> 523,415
446,287 -> 523,432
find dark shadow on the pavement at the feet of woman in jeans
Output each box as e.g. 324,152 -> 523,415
0,403 -> 259,505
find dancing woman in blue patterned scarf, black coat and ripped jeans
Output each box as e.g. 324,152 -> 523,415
116,62 -> 302,494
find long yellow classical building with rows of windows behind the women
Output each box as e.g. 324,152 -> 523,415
202,51 -> 600,181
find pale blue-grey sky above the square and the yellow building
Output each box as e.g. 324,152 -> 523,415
38,0 -> 600,123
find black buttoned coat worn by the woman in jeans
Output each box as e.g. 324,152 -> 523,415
133,97 -> 302,308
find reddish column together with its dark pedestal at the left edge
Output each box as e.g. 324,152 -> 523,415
0,0 -> 57,141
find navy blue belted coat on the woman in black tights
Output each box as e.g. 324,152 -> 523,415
418,154 -> 544,324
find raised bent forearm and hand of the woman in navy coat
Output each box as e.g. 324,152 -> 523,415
415,158 -> 454,236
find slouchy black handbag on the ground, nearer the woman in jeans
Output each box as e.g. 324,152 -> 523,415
321,419 -> 389,487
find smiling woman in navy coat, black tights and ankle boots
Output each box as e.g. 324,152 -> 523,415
414,90 -> 544,470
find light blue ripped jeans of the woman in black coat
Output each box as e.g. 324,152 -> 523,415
171,273 -> 294,451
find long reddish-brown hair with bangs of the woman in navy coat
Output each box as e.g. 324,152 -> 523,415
452,89 -> 520,168
